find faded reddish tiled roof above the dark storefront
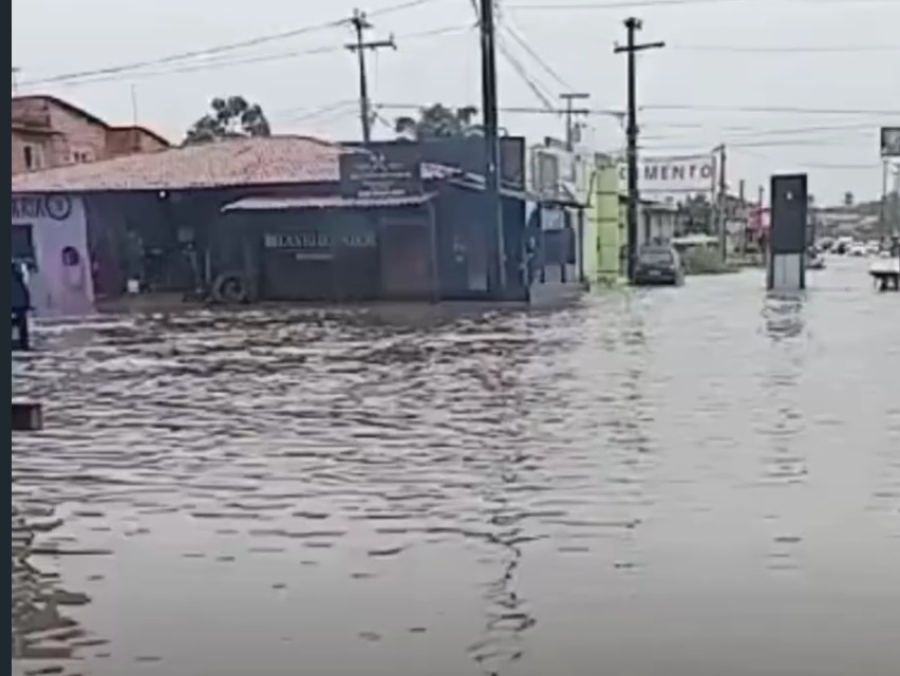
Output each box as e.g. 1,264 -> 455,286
12,136 -> 356,192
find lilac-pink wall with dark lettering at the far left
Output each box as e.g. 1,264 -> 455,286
12,195 -> 94,317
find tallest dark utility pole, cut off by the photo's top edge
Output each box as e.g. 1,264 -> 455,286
478,0 -> 506,293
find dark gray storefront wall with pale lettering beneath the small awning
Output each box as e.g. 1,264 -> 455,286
213,195 -> 438,301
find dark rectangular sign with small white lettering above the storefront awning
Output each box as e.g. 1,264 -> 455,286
340,151 -> 422,199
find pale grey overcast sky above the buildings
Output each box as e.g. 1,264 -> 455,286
12,0 -> 900,203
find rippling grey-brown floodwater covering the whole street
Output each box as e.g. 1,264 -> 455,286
12,255 -> 900,676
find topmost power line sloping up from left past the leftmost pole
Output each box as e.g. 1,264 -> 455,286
20,0 -> 454,85
